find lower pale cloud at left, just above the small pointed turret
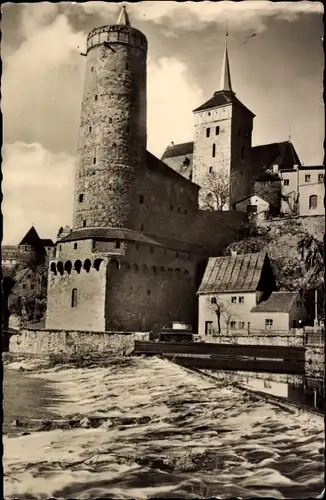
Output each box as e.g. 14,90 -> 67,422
2,142 -> 75,245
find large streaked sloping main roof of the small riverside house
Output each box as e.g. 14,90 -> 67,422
198,252 -> 269,294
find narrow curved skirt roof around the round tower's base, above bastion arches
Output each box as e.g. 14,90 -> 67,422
58,227 -> 202,253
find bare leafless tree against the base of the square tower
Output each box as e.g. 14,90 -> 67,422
200,168 -> 232,211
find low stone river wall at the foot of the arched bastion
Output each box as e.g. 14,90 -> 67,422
9,329 -> 149,354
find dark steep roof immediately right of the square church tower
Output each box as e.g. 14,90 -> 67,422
251,141 -> 301,175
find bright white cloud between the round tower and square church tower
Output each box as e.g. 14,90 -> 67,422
147,58 -> 204,157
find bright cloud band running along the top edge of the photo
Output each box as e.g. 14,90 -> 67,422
82,0 -> 323,31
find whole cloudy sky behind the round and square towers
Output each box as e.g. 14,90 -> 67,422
1,0 -> 324,245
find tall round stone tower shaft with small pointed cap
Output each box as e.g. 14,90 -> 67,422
73,7 -> 147,229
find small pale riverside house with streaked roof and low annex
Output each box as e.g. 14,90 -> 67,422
197,252 -> 307,341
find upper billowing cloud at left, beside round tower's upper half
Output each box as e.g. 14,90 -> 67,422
2,13 -> 85,151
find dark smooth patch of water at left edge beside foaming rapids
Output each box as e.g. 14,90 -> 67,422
3,367 -> 56,434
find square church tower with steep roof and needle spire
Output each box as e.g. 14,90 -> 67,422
193,38 -> 255,209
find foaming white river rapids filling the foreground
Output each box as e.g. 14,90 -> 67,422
3,358 -> 324,500
